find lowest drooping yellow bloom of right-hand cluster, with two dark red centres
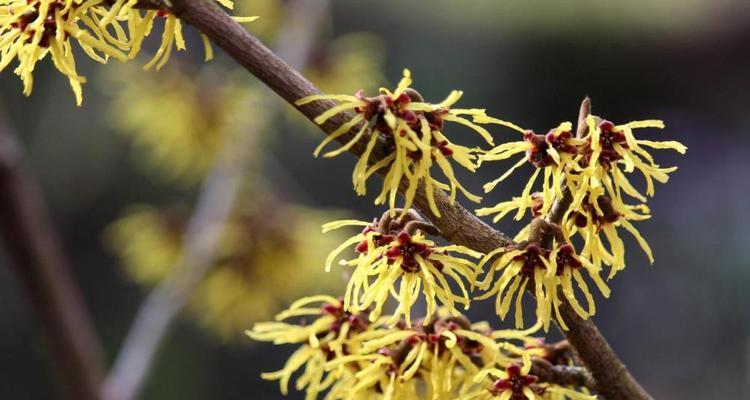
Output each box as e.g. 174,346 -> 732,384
476,231 -> 610,331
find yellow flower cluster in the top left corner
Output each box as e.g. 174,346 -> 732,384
0,0 -> 255,105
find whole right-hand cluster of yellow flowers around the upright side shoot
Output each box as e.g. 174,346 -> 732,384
475,103 -> 686,330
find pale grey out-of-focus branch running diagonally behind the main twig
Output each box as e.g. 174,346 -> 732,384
105,0 -> 328,400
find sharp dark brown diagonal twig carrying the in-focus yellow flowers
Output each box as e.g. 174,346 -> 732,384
173,0 -> 650,400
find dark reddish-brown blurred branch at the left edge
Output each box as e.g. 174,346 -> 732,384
0,105 -> 104,400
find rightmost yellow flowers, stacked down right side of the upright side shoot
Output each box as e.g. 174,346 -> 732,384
562,115 -> 687,278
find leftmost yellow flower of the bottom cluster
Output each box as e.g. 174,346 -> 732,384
246,295 -> 376,400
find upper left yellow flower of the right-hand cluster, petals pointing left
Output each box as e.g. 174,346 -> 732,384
474,120 -> 584,222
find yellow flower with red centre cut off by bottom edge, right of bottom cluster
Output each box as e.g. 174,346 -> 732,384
460,354 -> 596,400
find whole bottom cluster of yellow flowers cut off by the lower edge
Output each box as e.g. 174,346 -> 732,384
247,296 -> 594,400
